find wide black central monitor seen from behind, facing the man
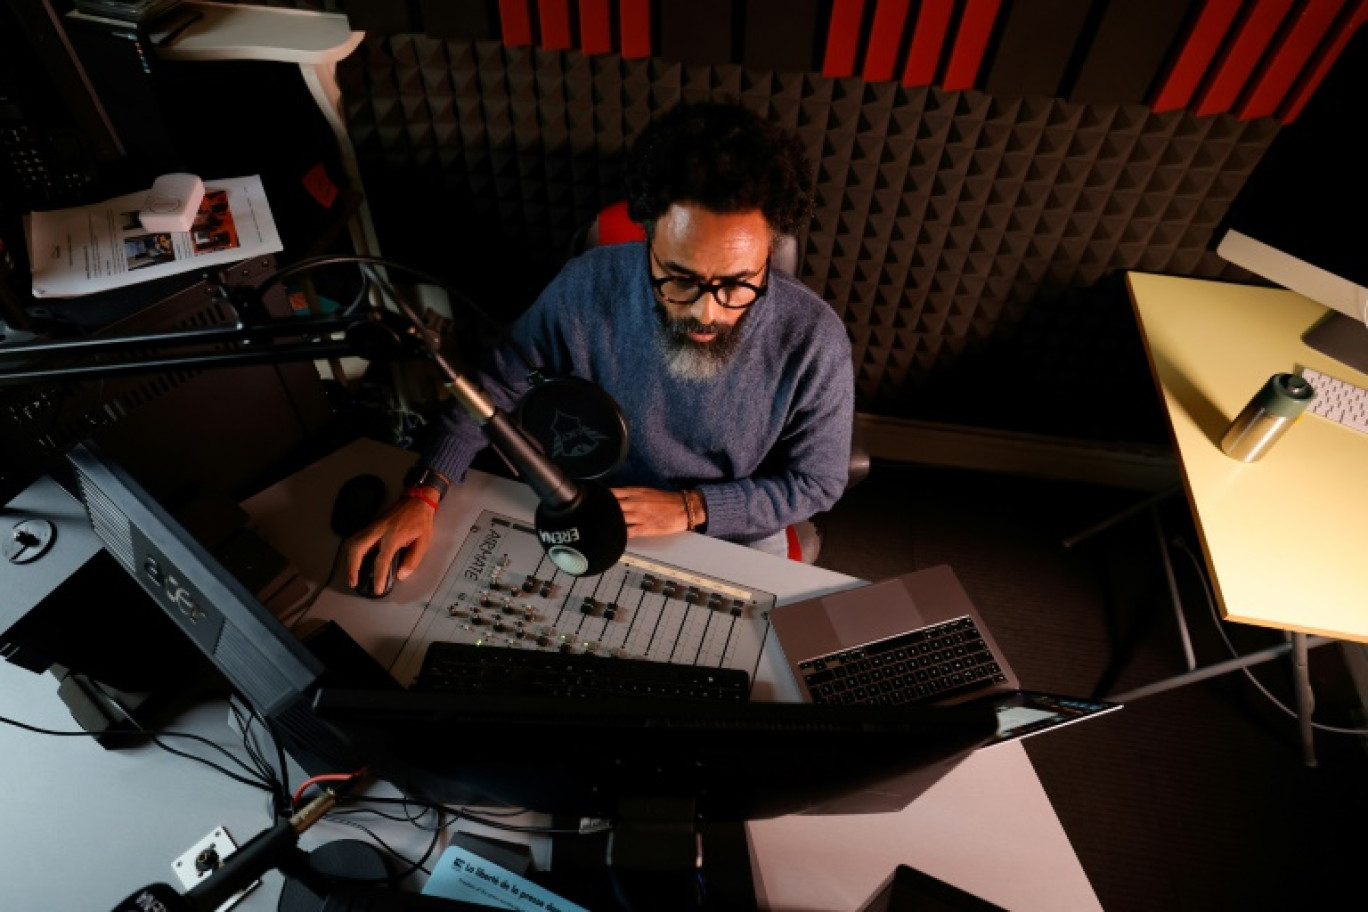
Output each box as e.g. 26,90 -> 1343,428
315,691 -> 997,820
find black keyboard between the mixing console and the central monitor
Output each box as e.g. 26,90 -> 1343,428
410,643 -> 750,700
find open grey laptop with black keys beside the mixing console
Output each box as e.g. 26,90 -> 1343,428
770,565 -> 1120,747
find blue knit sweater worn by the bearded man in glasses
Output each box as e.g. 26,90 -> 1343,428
423,243 -> 855,543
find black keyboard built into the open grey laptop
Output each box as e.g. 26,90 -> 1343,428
798,617 -> 1007,706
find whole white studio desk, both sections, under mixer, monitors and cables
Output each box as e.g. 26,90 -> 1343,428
0,440 -> 1100,912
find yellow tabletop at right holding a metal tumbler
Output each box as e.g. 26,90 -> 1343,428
1129,272 -> 1368,641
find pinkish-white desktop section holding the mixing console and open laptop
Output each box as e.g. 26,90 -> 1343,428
244,440 -> 1100,912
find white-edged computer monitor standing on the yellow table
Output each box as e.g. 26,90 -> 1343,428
1216,30 -> 1368,372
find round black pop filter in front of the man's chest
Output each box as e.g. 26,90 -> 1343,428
516,377 -> 628,480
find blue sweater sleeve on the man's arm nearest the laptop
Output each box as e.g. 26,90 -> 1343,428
699,323 -> 855,541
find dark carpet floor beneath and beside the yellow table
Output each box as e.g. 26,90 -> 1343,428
818,464 -> 1368,912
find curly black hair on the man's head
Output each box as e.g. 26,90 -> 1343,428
624,101 -> 813,234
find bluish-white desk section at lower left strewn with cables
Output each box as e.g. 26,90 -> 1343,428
0,648 -> 430,912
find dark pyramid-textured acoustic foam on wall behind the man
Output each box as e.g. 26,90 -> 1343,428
339,36 -> 1278,439
